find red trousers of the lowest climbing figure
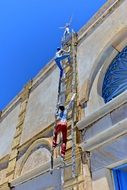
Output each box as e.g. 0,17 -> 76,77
53,122 -> 67,157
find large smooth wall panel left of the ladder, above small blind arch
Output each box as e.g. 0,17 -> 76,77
21,69 -> 59,144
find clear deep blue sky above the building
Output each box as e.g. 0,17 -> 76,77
0,0 -> 106,110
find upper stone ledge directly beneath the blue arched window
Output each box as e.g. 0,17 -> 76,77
77,91 -> 127,130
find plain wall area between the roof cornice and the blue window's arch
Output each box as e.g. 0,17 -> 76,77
77,1 -> 127,105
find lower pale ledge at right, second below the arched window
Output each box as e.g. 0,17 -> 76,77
80,118 -> 127,151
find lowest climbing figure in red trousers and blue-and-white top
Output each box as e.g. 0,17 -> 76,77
52,94 -> 76,158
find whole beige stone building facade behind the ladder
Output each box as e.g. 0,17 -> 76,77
0,0 -> 127,190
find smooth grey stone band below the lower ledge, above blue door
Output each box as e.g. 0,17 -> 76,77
91,134 -> 127,171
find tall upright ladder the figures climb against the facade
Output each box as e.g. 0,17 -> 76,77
50,32 -> 77,186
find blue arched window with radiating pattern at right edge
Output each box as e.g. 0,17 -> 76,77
102,46 -> 127,103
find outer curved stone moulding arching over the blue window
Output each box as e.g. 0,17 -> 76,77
80,27 -> 127,104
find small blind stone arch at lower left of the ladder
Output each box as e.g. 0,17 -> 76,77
15,139 -> 51,178
